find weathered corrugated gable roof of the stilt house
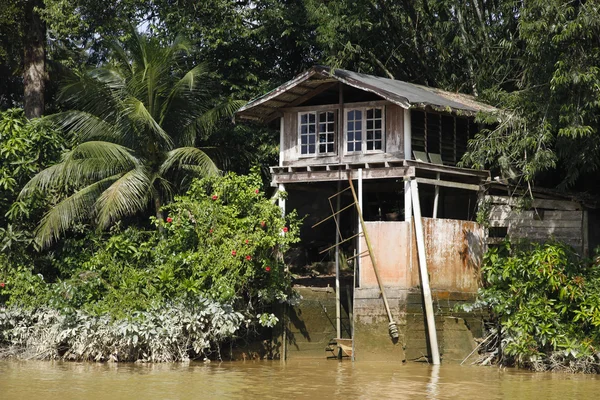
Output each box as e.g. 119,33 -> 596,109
236,66 -> 496,121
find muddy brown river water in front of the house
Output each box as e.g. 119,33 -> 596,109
0,360 -> 600,400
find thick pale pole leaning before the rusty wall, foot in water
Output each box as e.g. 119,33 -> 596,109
410,181 -> 440,365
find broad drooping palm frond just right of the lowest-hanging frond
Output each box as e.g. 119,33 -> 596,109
95,167 -> 152,228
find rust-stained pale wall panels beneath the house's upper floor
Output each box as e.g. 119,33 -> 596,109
360,218 -> 485,292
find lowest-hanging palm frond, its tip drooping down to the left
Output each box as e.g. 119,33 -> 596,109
35,176 -> 118,247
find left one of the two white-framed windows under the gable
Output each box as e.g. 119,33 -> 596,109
298,111 -> 336,157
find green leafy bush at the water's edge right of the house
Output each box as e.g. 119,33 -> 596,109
477,238 -> 600,371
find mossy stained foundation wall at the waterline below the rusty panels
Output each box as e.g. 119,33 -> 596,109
287,288 -> 482,363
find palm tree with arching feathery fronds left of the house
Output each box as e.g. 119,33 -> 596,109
20,32 -> 241,246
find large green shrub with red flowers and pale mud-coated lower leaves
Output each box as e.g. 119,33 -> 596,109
0,170 -> 300,361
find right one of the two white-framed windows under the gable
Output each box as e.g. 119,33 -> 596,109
345,107 -> 385,153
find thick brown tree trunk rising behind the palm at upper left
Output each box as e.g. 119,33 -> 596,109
23,0 -> 46,118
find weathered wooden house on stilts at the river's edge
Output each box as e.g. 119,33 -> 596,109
236,66 -> 596,363
